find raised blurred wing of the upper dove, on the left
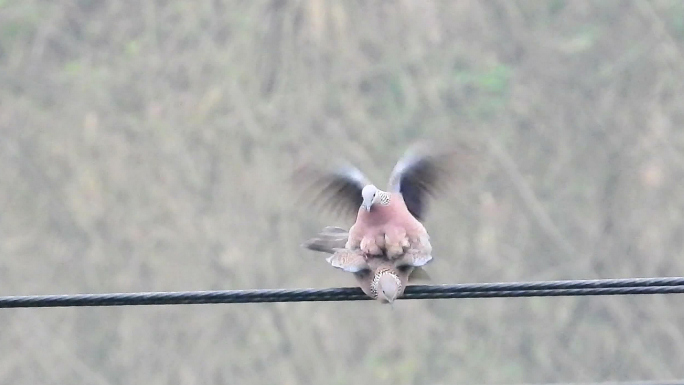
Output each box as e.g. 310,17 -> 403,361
294,164 -> 370,217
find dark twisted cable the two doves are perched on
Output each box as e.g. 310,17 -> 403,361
0,277 -> 684,308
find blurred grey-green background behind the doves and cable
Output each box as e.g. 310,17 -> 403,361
0,0 -> 684,385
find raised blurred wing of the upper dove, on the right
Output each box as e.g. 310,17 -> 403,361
389,144 -> 458,222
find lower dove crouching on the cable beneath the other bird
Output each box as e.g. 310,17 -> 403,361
302,226 -> 432,304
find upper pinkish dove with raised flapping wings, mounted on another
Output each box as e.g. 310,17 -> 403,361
295,143 -> 459,259
